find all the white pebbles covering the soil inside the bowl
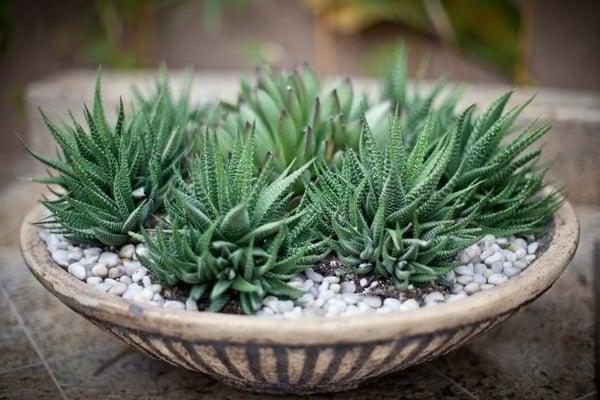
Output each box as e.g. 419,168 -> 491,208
40,231 -> 540,319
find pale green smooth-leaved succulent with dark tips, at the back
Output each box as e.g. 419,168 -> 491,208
218,66 -> 389,176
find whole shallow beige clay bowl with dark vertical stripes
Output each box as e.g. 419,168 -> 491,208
21,203 -> 579,394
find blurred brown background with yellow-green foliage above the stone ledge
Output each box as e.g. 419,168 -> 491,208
0,0 -> 600,177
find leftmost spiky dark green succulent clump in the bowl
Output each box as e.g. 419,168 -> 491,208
24,76 -> 189,246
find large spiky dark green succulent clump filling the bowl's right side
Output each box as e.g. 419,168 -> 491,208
307,93 -> 563,286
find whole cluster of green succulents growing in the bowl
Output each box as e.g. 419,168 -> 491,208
32,50 -> 563,314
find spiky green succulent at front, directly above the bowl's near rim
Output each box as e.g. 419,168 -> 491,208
137,133 -> 327,314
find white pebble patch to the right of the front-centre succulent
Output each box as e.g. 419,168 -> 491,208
253,235 -> 539,318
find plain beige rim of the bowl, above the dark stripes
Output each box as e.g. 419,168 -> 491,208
20,201 -> 579,346
